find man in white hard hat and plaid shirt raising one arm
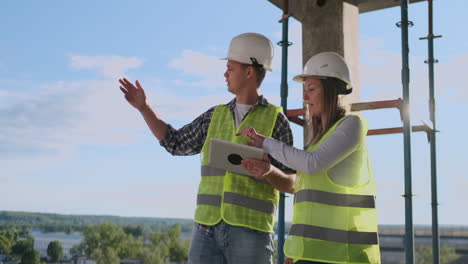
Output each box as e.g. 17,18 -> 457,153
119,33 -> 294,264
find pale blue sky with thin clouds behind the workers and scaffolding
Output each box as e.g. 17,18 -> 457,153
0,0 -> 468,225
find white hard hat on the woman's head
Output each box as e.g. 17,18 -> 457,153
293,52 -> 353,94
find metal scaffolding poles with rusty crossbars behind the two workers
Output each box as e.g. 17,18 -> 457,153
277,0 -> 441,264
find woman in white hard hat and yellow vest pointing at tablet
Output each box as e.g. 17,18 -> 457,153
238,52 -> 380,263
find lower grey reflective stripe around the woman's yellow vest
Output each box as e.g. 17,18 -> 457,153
289,224 -> 379,245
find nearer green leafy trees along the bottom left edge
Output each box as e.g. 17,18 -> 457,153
0,222 -> 190,264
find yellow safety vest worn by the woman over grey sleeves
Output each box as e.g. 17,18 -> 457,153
284,116 -> 380,263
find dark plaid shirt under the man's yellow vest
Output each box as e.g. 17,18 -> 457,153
160,96 -> 294,171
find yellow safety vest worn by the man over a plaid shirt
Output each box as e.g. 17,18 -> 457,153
195,104 -> 281,232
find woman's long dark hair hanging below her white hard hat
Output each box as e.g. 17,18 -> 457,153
311,78 -> 346,145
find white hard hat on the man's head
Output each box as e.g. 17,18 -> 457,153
223,33 -> 273,71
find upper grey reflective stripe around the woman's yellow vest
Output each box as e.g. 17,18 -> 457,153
294,189 -> 375,208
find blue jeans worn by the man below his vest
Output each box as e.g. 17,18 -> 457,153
189,221 -> 274,264
